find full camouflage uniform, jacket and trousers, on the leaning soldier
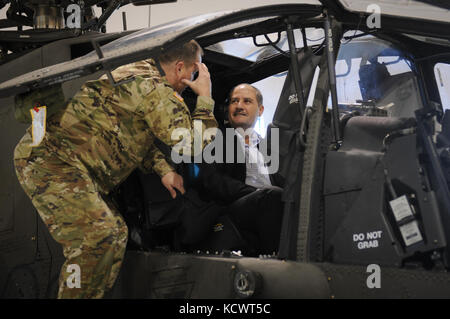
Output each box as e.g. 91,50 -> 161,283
14,59 -> 217,298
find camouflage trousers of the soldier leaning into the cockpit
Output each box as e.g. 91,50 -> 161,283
14,148 -> 128,298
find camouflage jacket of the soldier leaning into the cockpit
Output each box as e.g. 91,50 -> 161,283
14,59 -> 217,193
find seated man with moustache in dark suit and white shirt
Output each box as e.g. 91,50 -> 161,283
199,84 -> 283,254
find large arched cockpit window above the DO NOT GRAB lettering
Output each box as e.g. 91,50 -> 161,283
336,36 -> 422,117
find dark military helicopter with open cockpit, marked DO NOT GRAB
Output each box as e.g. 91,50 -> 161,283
0,0 -> 450,299
